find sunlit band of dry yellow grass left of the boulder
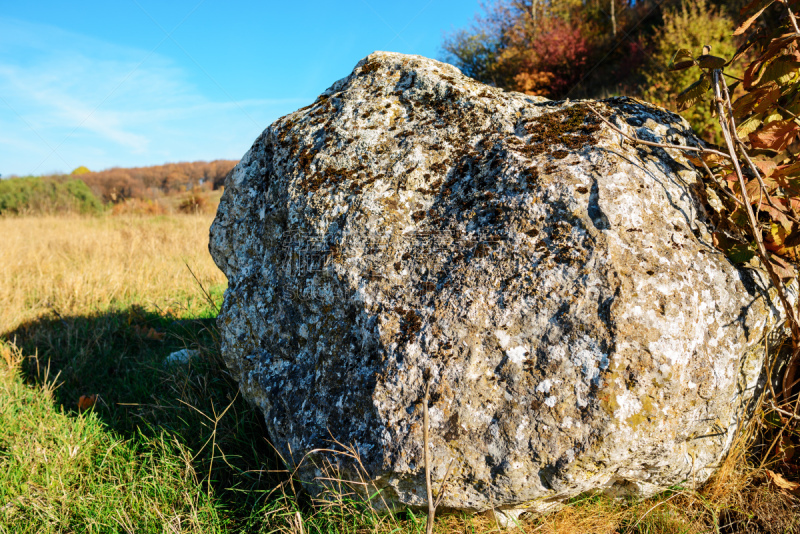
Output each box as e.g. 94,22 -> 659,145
0,214 -> 225,333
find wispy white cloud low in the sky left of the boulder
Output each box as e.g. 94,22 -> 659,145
0,17 -> 312,174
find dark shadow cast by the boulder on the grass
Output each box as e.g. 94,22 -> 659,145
0,305 -> 286,519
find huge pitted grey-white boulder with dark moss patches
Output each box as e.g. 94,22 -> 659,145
210,52 -> 778,511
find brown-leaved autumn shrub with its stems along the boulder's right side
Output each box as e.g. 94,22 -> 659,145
652,0 -> 800,482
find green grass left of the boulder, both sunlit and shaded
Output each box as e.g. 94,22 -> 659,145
0,286 -> 432,534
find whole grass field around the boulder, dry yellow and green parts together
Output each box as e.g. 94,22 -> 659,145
0,215 -> 798,534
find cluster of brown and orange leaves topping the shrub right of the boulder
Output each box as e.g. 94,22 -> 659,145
670,0 -> 800,277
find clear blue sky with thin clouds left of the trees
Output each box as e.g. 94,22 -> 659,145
0,0 -> 479,176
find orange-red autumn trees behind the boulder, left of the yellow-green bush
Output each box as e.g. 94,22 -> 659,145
442,0 -> 660,98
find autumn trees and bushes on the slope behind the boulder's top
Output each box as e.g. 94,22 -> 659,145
442,0 -> 778,143
